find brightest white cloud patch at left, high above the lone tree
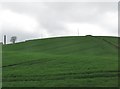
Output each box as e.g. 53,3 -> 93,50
0,10 -> 38,33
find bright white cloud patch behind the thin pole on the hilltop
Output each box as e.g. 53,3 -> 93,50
66,23 -> 113,36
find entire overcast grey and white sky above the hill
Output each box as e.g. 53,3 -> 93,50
0,2 -> 118,43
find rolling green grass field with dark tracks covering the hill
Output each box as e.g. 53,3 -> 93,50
2,36 -> 118,87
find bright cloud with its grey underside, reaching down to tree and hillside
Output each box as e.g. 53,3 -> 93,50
0,5 -> 47,41
